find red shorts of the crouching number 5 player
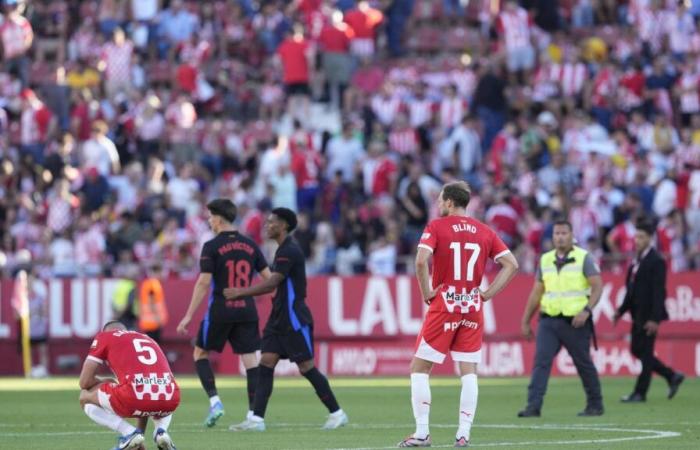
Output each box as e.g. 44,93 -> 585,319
97,383 -> 180,419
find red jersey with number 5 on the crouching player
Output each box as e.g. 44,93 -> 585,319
88,330 -> 178,401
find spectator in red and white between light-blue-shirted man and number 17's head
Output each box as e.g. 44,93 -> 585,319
362,140 -> 398,198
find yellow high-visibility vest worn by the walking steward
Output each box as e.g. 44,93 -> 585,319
540,246 -> 591,317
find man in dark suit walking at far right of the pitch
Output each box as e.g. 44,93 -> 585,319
614,218 -> 685,403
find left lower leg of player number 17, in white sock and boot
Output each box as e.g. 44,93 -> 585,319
399,356 -> 433,447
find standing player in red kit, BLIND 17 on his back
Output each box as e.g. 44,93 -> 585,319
399,182 -> 518,447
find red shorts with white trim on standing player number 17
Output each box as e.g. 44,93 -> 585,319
415,311 -> 483,364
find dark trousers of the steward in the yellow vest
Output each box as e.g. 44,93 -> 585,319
527,316 -> 603,410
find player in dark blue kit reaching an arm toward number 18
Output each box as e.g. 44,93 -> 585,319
224,208 -> 348,431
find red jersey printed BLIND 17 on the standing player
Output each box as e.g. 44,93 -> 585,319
418,216 -> 510,316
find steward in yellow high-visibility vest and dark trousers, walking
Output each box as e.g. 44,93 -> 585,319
518,220 -> 603,417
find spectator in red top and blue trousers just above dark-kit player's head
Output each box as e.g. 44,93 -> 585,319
290,132 -> 321,214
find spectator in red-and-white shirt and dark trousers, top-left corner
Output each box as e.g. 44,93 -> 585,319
0,0 -> 34,87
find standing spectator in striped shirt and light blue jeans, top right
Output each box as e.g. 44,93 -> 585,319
496,0 -> 535,80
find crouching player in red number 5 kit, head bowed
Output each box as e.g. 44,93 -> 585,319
80,321 -> 180,450
